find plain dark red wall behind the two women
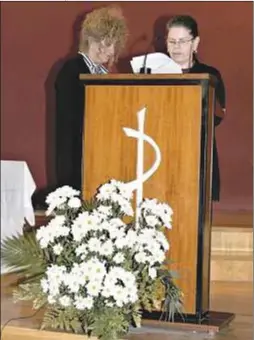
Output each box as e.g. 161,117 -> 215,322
1,1 -> 253,210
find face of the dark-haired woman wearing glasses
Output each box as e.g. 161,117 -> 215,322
167,26 -> 199,68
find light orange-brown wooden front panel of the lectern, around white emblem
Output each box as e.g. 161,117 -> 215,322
82,85 -> 202,314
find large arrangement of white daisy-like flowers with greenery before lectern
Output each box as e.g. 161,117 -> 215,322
3,180 -> 182,340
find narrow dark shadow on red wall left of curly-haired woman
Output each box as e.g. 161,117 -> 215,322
33,11 -> 89,209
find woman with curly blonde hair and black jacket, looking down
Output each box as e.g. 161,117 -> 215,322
55,7 -> 127,189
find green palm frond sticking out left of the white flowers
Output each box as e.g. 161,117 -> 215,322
1,231 -> 46,281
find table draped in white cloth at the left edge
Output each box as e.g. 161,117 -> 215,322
1,161 -> 36,274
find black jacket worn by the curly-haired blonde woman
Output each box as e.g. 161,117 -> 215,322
55,54 -> 90,190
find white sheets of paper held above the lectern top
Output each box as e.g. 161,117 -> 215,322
130,52 -> 183,74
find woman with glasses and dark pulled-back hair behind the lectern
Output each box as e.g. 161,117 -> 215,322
166,15 -> 226,201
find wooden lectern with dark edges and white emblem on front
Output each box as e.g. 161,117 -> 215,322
80,74 -> 215,318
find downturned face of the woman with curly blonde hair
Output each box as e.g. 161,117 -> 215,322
89,40 -> 115,64
